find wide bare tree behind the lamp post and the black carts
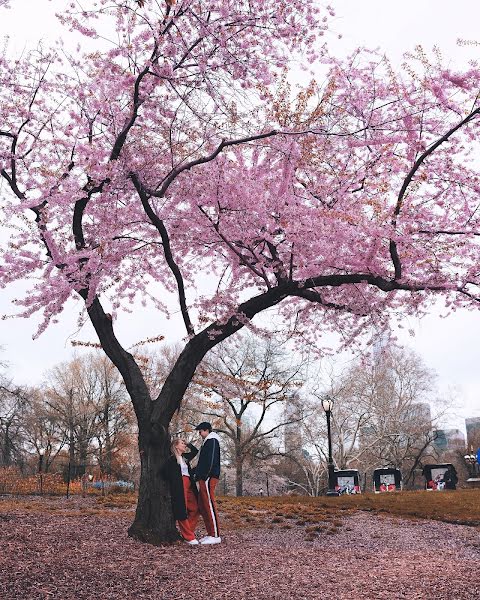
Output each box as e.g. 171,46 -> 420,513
294,347 -> 444,493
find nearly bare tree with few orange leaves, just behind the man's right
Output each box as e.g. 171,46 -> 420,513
194,334 -> 303,496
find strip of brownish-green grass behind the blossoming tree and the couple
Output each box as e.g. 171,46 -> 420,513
0,490 -> 480,536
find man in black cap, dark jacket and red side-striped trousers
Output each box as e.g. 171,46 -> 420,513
195,421 -> 222,544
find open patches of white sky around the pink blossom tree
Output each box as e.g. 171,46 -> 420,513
0,0 -> 480,428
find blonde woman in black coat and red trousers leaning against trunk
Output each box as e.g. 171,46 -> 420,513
162,438 -> 200,546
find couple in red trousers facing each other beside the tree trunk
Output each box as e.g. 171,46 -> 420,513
163,421 -> 222,546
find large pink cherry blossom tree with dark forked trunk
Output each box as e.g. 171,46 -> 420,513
0,0 -> 480,543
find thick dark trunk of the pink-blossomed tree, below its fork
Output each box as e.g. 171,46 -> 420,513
128,428 -> 180,546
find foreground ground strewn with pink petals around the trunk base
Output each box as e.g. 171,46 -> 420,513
0,499 -> 480,600
